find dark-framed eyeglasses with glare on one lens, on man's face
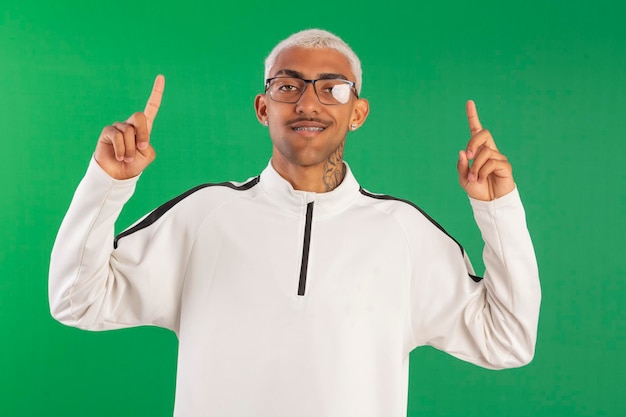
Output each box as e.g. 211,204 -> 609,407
265,77 -> 359,105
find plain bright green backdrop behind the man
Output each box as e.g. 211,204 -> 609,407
0,0 -> 626,417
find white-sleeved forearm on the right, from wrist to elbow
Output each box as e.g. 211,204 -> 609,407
466,189 -> 541,367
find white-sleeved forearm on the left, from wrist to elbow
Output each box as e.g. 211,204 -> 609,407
49,160 -> 136,328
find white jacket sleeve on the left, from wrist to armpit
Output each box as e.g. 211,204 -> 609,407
48,159 -> 185,331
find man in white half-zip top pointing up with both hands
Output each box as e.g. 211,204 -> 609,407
50,30 -> 540,417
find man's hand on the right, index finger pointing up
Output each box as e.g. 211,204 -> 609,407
457,100 -> 515,201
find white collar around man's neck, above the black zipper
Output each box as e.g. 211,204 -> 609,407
259,161 -> 360,218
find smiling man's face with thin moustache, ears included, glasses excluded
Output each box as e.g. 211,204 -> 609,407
255,47 -> 369,168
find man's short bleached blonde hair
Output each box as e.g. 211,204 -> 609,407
263,29 -> 363,95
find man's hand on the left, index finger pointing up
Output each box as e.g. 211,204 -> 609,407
94,75 -> 165,180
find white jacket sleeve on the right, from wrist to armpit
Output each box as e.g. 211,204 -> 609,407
412,189 -> 541,369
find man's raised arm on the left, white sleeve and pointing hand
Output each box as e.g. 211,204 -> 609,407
48,76 -> 185,330
